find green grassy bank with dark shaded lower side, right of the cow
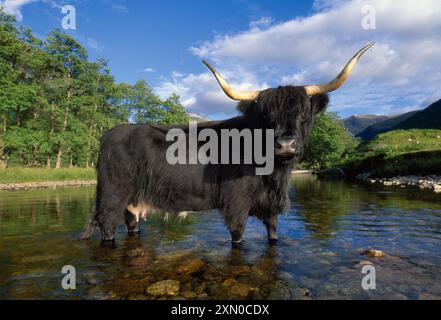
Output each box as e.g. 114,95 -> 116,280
341,130 -> 441,178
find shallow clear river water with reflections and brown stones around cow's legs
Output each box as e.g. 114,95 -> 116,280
0,176 -> 441,299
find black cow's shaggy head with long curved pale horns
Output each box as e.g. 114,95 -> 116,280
204,43 -> 374,162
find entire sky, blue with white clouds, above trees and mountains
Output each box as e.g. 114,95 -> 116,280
0,0 -> 441,118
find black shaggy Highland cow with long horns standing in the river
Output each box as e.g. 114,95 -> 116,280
82,44 -> 373,244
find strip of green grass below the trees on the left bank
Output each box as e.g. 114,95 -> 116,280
0,167 -> 96,183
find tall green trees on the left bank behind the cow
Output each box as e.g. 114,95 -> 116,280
0,12 -> 188,168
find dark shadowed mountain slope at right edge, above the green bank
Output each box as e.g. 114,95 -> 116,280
394,100 -> 441,130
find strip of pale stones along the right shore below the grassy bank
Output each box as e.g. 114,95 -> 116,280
356,174 -> 441,193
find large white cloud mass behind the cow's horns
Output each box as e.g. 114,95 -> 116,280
157,0 -> 441,115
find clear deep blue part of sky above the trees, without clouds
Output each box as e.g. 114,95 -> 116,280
14,0 -> 312,85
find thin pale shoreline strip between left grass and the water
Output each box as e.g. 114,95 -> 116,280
0,180 -> 96,191
